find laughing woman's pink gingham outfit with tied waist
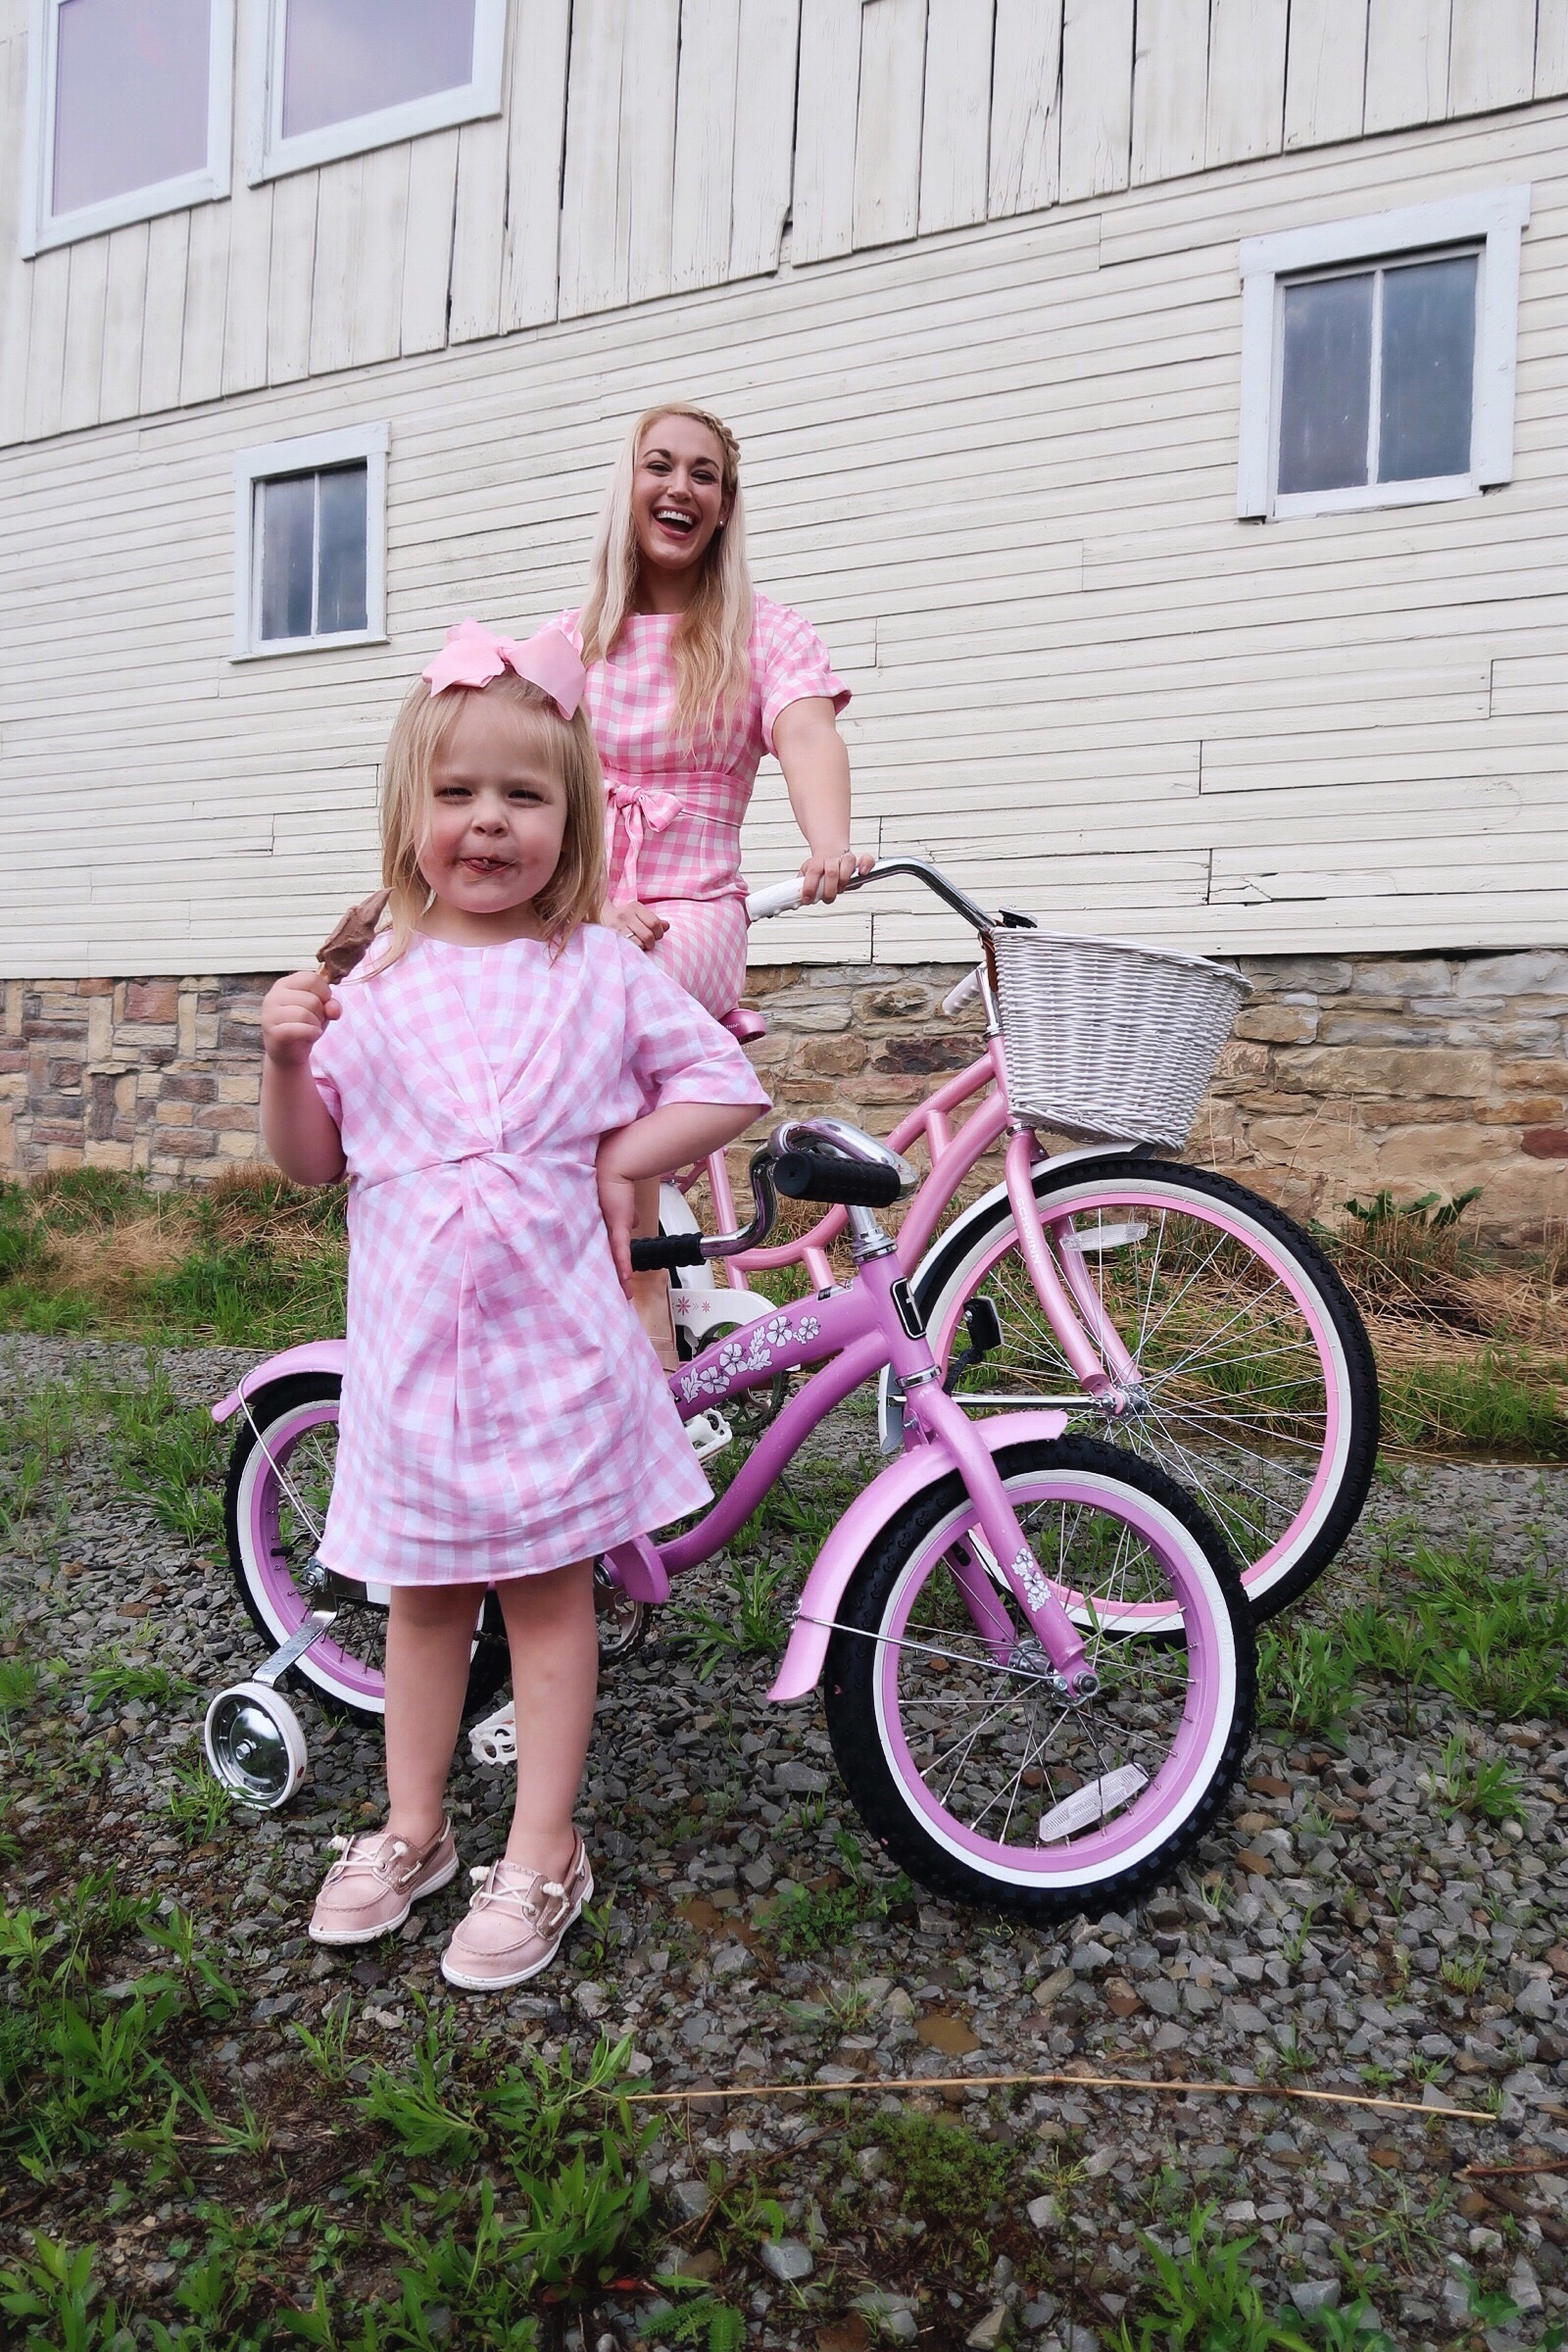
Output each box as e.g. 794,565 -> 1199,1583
562,595 -> 849,1013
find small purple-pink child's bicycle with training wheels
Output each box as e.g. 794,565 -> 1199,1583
207,1119 -> 1255,1922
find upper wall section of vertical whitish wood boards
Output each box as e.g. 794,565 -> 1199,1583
0,0 -> 1568,447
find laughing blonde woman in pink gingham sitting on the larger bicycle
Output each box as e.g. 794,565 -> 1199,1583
562,400 -> 872,1362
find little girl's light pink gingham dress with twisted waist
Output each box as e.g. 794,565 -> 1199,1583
311,924 -> 766,1586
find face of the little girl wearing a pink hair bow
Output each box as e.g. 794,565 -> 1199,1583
418,694 -> 566,946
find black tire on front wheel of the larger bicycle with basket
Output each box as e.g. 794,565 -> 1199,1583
912,1152 -> 1380,1625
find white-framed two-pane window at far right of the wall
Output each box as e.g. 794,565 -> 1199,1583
1237,188 -> 1531,517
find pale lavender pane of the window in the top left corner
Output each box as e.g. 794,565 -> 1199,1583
54,0 -> 212,214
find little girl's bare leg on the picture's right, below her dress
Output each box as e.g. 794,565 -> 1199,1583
496,1559 -> 600,1880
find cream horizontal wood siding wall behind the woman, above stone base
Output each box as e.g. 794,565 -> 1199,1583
0,108 -> 1568,976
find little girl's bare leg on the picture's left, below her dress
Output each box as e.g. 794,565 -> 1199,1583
385,1586 -> 484,1846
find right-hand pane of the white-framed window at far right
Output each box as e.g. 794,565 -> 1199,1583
1378,254 -> 1476,482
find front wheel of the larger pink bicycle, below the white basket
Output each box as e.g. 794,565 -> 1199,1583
888,1154 -> 1378,1621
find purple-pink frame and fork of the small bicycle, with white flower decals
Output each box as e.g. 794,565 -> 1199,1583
609,1251 -> 1089,1691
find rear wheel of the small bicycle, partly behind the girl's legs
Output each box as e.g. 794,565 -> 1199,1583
223,1371 -> 511,1715
